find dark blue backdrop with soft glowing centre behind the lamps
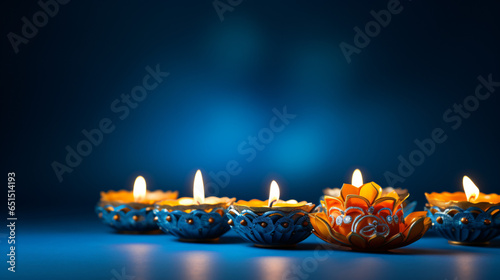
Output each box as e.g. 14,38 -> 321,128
0,0 -> 500,219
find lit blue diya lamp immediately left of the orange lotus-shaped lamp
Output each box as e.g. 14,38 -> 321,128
227,181 -> 315,247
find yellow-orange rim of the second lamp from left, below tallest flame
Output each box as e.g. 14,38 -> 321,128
155,196 -> 236,211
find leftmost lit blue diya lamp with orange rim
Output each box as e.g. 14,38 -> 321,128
95,176 -> 177,233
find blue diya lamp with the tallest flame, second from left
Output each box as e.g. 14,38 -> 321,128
154,170 -> 236,242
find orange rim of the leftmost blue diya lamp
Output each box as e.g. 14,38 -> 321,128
100,190 -> 179,205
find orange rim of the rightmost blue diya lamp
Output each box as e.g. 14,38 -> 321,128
425,192 -> 500,211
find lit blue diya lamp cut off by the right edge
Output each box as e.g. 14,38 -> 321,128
425,176 -> 500,245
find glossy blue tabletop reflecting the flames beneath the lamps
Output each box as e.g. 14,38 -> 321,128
0,220 -> 500,280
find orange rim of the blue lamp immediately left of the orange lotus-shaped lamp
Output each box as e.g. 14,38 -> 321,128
233,199 -> 316,214
